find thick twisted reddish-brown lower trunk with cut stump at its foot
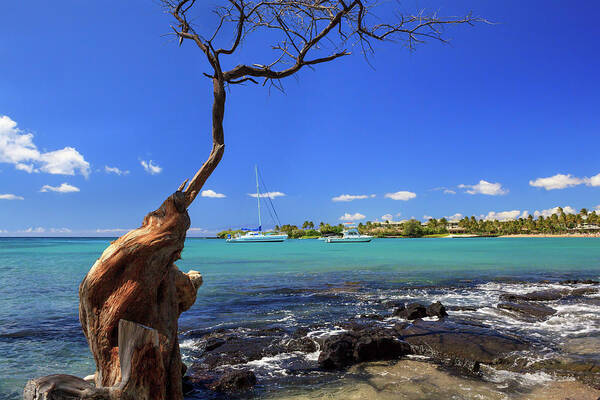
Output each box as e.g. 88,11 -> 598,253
24,191 -> 202,400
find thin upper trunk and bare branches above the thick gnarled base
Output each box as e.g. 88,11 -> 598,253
161,0 -> 483,205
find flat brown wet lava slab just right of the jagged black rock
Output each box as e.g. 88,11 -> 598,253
394,319 -> 530,373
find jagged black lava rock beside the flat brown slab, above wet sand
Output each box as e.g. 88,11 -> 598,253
319,329 -> 411,369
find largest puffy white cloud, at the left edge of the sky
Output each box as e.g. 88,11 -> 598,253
0,115 -> 90,177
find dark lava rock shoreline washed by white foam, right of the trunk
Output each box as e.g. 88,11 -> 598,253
179,280 -> 600,398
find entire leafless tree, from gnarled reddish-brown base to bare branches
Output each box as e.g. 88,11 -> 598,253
25,0 -> 480,400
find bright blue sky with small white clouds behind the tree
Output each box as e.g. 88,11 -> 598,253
0,0 -> 600,236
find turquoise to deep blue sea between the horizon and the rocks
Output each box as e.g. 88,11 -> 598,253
0,238 -> 600,399
